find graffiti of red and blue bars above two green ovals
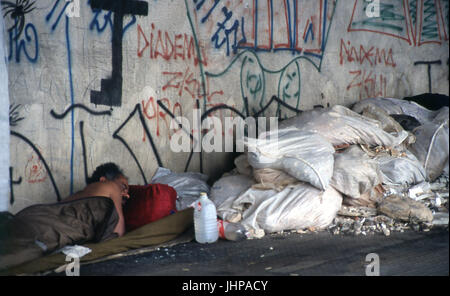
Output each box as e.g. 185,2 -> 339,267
186,0 -> 337,117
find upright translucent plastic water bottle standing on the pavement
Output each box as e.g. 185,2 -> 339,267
194,192 -> 219,244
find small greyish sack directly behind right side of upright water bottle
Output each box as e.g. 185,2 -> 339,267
209,175 -> 255,207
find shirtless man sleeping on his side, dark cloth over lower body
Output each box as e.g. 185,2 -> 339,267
0,163 -> 129,271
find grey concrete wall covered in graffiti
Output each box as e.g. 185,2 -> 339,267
3,0 -> 450,212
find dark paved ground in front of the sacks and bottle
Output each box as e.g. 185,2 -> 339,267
74,229 -> 449,276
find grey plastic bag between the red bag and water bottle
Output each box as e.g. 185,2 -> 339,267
151,167 -> 210,211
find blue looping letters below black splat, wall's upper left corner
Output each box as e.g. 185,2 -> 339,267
8,23 -> 39,63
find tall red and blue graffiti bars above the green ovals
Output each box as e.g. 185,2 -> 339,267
192,0 -> 336,62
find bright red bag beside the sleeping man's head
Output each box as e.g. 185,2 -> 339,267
123,184 -> 177,232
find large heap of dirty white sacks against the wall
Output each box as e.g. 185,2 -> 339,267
210,98 -> 449,237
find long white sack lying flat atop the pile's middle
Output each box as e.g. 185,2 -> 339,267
278,105 -> 408,147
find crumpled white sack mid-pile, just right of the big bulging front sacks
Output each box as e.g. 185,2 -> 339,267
330,145 -> 381,198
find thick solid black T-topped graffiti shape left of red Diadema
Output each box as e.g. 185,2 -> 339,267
90,0 -> 148,106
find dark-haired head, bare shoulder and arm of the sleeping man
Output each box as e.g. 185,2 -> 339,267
64,162 -> 130,236
